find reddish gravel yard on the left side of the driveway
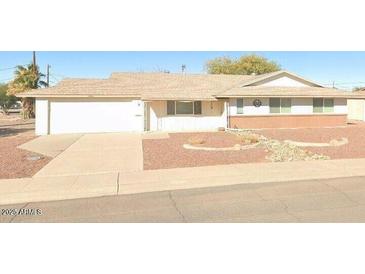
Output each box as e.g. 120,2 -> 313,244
0,115 -> 50,179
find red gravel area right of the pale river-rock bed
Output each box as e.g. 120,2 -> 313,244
256,122 -> 365,159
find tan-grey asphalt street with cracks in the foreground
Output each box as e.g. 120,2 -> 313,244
0,177 -> 365,223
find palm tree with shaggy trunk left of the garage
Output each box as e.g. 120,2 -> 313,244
8,64 -> 47,119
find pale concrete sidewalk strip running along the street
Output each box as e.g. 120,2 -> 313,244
0,159 -> 365,205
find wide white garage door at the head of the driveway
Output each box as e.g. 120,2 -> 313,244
50,99 -> 143,134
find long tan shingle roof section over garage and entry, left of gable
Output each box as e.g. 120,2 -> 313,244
18,73 -> 255,100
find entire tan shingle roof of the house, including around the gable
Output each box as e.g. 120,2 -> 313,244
17,71 -> 364,100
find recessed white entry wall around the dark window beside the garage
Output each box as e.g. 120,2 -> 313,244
148,100 -> 227,131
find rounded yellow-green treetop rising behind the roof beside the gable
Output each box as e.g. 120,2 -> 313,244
206,54 -> 280,75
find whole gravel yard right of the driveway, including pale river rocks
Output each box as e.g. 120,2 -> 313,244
143,122 -> 365,169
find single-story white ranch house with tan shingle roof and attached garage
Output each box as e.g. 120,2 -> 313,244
19,71 -> 365,135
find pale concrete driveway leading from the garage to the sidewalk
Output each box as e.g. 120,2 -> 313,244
34,133 -> 143,178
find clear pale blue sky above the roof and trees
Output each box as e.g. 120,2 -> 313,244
0,51 -> 365,90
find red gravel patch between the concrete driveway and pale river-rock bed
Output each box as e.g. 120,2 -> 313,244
143,132 -> 267,169
